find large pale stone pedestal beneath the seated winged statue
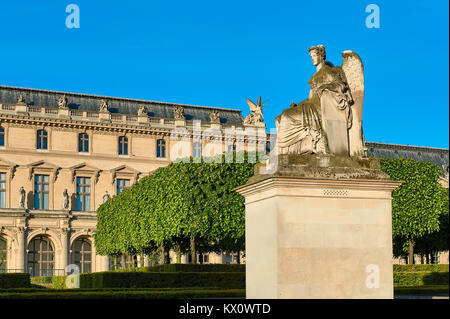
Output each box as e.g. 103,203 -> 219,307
237,155 -> 399,299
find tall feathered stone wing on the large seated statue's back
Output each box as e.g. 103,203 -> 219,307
342,51 -> 364,155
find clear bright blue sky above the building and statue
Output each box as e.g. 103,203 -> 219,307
0,0 -> 449,148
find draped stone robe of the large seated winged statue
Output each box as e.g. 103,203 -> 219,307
275,64 -> 353,154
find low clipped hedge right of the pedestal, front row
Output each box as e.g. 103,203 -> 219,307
394,271 -> 449,286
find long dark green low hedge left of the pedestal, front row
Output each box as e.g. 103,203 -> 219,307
80,272 -> 245,289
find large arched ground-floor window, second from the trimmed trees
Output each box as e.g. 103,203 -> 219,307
27,236 -> 55,277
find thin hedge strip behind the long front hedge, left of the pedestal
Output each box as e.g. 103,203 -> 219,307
115,264 -> 245,272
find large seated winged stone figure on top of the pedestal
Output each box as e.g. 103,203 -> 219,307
275,45 -> 364,156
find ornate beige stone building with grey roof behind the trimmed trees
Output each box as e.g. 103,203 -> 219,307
0,86 -> 448,276
